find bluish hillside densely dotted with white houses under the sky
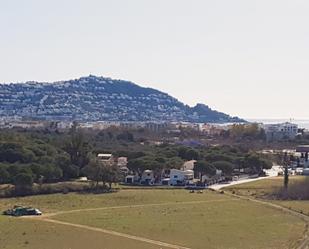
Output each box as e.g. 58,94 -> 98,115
0,75 -> 244,123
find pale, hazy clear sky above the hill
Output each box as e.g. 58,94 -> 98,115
0,0 -> 309,119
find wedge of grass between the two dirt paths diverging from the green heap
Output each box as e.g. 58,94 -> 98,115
54,197 -> 304,249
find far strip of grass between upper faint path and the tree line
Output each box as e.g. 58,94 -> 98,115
0,189 -> 218,213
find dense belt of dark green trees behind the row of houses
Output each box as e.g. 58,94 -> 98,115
0,126 -> 272,196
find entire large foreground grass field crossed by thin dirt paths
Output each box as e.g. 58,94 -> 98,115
0,190 -> 305,249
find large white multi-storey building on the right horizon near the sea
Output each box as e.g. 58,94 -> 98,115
263,122 -> 298,140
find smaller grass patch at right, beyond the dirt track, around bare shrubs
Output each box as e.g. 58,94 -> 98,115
226,176 -> 309,215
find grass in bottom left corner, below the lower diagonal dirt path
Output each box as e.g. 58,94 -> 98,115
0,216 -> 167,249
